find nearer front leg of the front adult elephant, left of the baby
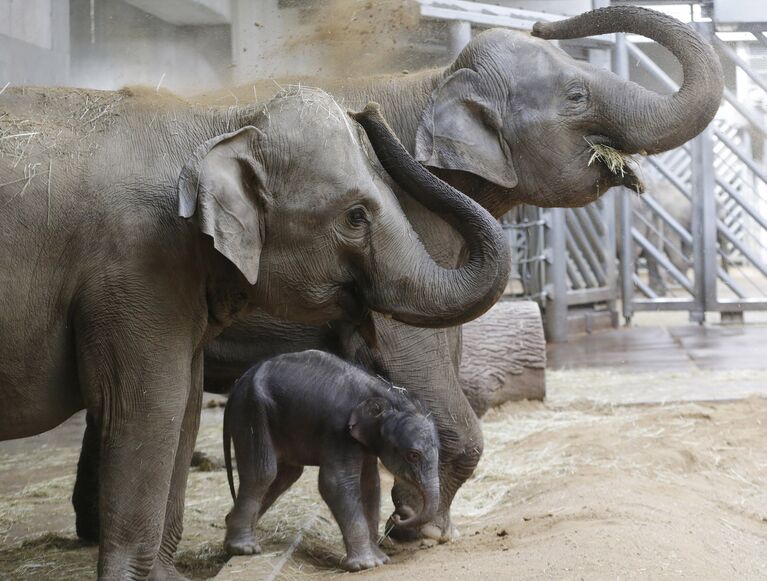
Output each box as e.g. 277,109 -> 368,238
88,353 -> 191,580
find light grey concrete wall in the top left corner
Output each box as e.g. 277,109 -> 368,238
0,0 -> 69,89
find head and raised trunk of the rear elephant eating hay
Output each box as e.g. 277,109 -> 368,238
415,6 -> 723,208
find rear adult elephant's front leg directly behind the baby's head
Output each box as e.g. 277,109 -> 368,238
342,315 -> 483,541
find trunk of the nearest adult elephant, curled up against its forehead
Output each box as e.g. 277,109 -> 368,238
354,103 -> 510,327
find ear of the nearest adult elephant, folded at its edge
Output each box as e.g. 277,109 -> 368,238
177,127 -> 265,284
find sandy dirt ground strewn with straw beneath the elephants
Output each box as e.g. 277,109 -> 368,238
0,370 -> 767,581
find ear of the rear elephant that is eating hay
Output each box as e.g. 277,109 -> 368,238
415,69 -> 518,188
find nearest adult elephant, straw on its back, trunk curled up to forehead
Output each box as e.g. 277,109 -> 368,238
0,88 -> 508,580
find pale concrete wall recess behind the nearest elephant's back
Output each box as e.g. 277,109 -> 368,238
70,0 -> 231,92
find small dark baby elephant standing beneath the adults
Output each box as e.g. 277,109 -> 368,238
224,351 -> 439,571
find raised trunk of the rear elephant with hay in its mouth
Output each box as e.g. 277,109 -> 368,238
533,6 -> 724,153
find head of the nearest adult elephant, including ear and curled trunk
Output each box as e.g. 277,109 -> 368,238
178,87 -> 509,327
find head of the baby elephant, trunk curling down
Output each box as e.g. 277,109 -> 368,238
349,397 -> 439,527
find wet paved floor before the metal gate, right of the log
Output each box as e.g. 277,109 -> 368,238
547,323 -> 767,404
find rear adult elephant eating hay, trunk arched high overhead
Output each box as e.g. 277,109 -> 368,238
75,6 -> 723,539
